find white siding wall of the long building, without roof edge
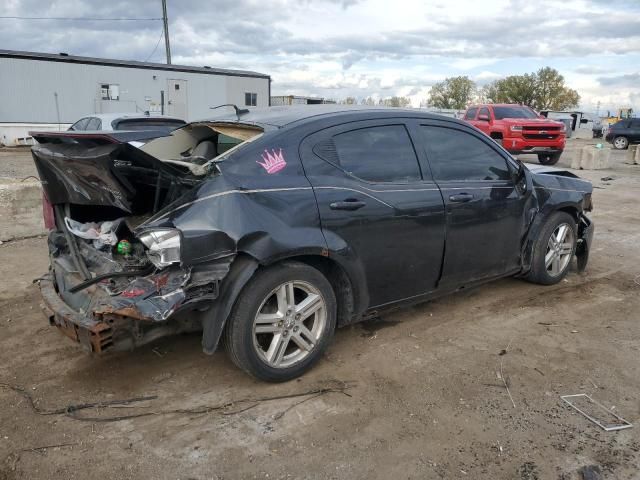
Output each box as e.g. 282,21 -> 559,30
0,58 -> 269,123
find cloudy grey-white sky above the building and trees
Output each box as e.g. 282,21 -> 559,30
0,0 -> 640,112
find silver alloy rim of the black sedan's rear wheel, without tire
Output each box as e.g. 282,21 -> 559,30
253,281 -> 327,368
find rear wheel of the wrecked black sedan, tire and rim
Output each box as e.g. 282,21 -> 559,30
225,262 -> 336,382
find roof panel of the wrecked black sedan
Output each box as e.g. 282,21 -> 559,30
193,104 -> 460,128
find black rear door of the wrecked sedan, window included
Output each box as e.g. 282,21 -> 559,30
301,119 -> 444,307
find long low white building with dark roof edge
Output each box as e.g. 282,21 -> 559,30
0,50 -> 271,145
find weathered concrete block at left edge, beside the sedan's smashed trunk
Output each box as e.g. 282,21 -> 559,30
0,180 -> 46,242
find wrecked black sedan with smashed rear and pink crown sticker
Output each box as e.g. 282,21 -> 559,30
33,105 -> 593,381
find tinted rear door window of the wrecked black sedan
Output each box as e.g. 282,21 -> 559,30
330,125 -> 421,183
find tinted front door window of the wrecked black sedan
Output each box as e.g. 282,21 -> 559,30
420,125 -> 510,181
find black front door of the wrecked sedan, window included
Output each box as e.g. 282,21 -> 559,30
417,121 -> 531,287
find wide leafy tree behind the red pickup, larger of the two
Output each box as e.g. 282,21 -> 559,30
481,67 -> 580,110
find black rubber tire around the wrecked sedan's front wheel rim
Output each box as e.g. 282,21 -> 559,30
526,212 -> 578,285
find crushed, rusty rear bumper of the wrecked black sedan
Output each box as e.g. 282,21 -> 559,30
40,259 -> 231,354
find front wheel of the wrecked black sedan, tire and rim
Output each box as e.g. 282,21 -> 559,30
527,212 -> 577,285
